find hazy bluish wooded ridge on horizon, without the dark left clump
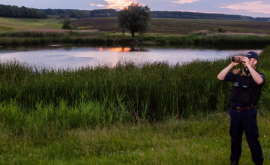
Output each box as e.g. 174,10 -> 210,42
41,9 -> 270,21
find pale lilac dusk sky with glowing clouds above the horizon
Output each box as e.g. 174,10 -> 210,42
0,0 -> 270,17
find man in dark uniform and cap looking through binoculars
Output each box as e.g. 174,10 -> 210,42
217,51 -> 265,165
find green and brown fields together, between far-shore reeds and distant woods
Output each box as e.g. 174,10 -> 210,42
3,17 -> 270,35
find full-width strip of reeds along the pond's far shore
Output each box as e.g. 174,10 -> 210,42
0,31 -> 270,49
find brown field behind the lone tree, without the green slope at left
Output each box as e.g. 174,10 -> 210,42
72,18 -> 270,35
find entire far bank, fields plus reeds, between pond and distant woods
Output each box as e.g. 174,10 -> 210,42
0,18 -> 270,49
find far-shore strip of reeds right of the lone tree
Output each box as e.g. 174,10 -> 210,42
140,34 -> 270,49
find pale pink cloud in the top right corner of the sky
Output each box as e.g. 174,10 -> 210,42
221,1 -> 270,14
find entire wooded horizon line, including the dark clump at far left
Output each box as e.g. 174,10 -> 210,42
0,4 -> 270,21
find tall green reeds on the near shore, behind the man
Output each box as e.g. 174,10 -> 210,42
0,47 -> 270,134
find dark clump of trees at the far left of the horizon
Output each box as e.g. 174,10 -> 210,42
0,4 -> 48,18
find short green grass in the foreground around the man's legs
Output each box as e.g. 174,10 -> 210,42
0,113 -> 270,165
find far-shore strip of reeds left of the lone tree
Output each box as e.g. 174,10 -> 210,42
0,35 -> 138,46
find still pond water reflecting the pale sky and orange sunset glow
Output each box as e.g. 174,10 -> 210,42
0,45 -> 261,69
